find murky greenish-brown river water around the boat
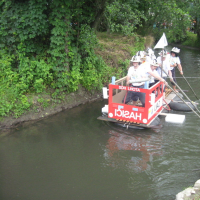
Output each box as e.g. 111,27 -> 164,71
0,47 -> 200,200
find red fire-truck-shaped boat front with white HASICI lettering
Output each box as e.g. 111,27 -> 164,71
98,77 -> 187,128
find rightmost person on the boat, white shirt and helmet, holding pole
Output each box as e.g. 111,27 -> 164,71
170,47 -> 183,92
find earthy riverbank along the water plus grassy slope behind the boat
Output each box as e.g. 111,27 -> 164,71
0,33 -> 154,130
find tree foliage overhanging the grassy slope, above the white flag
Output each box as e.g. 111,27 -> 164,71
98,0 -> 191,42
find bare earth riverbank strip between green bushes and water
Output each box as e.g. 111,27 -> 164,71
0,86 -> 102,133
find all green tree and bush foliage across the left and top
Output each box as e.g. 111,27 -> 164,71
0,0 -> 197,116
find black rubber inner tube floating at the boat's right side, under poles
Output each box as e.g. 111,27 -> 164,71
169,101 -> 196,112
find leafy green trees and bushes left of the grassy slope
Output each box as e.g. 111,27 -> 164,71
0,0 -> 123,116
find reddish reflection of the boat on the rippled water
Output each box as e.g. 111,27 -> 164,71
104,130 -> 163,172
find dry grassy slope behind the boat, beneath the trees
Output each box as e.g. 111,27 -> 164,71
95,32 -> 154,68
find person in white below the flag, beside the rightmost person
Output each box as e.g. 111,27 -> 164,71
157,50 -> 172,99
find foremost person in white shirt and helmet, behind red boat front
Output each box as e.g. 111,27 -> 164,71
122,56 -> 167,107
